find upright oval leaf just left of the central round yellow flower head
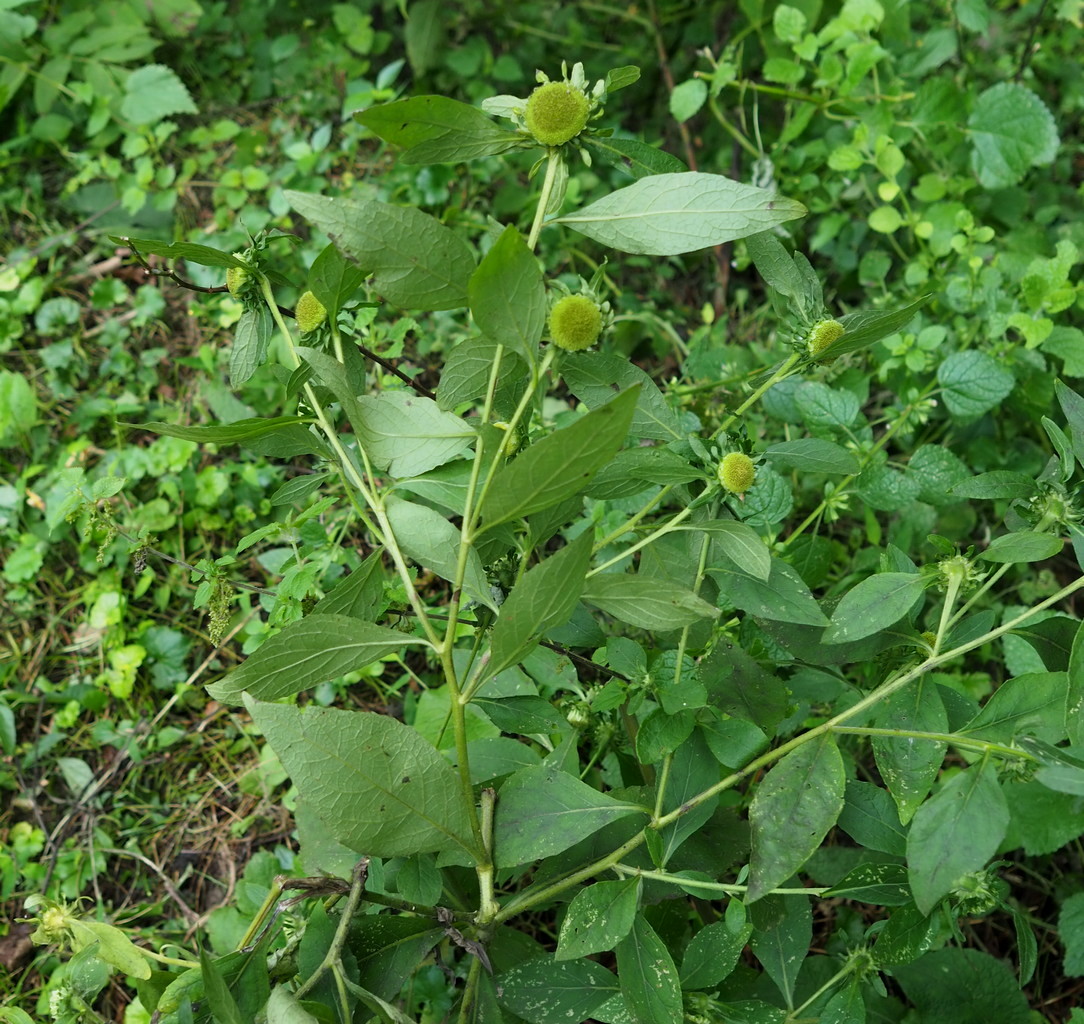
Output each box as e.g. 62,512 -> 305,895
470,225 -> 546,365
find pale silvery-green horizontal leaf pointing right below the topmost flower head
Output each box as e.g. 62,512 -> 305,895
553,171 -> 805,256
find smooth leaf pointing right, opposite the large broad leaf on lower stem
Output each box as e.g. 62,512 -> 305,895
494,764 -> 646,868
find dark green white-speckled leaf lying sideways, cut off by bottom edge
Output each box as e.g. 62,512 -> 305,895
496,957 -> 618,1024
